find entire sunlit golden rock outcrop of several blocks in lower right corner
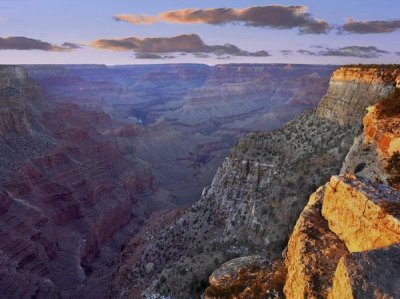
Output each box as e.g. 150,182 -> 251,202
284,175 -> 400,298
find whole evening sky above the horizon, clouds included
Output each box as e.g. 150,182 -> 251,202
0,0 -> 400,65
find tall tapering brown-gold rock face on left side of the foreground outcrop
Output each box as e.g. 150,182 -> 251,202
285,187 -> 348,298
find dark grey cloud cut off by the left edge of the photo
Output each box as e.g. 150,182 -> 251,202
0,36 -> 79,52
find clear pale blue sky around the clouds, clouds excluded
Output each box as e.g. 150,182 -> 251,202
0,0 -> 400,64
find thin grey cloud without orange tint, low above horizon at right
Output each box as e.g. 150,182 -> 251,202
297,46 -> 389,58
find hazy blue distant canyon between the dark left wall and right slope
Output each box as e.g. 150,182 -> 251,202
25,64 -> 334,210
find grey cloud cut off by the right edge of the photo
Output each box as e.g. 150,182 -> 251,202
339,19 -> 400,34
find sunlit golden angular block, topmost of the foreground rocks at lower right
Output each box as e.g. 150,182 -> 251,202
322,176 -> 400,252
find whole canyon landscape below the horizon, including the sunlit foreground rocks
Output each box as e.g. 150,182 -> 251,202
0,65 -> 400,299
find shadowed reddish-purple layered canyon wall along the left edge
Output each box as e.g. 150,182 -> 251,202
0,66 -> 154,298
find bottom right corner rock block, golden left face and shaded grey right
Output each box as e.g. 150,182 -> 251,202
328,245 -> 400,299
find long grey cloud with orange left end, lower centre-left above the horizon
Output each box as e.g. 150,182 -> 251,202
91,34 -> 270,57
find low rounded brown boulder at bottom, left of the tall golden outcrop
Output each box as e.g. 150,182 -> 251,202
204,256 -> 285,299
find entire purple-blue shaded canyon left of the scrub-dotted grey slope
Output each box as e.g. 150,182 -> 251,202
0,65 -> 333,298
